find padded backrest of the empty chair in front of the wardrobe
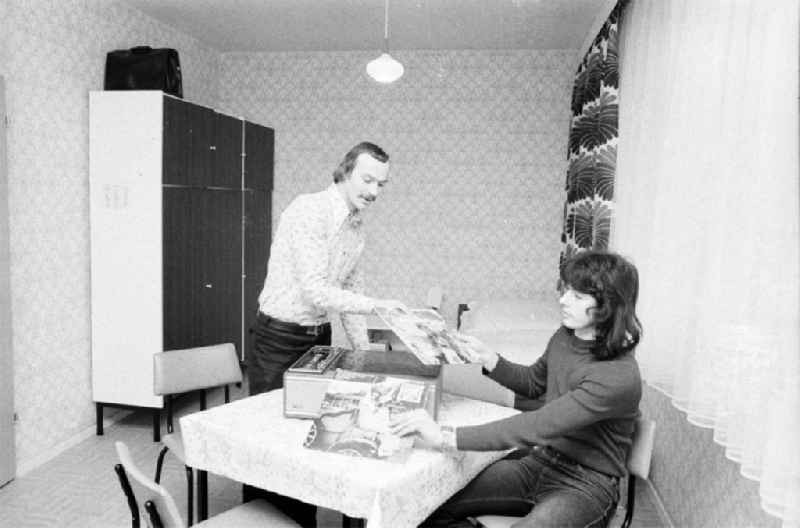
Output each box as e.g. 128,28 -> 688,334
153,343 -> 242,396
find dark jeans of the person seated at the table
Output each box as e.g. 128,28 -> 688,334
420,446 -> 619,528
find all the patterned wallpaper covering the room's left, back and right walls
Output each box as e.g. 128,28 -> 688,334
0,7 -> 777,527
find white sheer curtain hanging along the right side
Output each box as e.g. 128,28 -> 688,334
612,0 -> 800,528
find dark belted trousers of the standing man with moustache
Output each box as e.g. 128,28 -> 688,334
242,312 -> 331,528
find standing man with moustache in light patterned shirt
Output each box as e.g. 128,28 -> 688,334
248,142 -> 405,394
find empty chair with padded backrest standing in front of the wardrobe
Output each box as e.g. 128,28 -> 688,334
153,343 -> 242,526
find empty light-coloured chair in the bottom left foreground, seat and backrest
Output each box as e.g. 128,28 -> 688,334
114,441 -> 300,528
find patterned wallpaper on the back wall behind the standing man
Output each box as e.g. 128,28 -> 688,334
220,50 -> 576,321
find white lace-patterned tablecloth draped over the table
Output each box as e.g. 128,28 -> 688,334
180,390 -> 518,528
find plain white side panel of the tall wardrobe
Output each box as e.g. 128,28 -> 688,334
89,90 -> 164,408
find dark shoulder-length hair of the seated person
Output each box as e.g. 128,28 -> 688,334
561,250 -> 642,359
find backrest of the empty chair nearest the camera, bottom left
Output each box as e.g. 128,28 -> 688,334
114,441 -> 186,528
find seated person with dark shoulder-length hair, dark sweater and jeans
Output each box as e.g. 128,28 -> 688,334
393,251 -> 642,528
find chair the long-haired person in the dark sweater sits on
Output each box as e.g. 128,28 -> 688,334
475,418 -> 656,528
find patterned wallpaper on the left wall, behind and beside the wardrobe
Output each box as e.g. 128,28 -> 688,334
0,0 -> 219,471
